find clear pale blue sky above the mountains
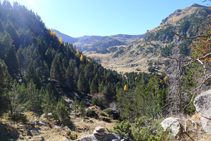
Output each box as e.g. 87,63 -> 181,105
9,0 -> 211,37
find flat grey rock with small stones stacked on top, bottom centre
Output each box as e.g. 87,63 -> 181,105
65,127 -> 132,141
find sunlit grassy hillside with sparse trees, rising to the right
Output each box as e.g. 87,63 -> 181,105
85,4 -> 211,72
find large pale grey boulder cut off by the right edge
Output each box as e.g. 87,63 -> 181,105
194,90 -> 211,134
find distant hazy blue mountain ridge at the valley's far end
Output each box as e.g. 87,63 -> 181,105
53,29 -> 144,53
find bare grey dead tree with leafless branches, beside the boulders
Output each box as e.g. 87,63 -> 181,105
166,32 -> 211,115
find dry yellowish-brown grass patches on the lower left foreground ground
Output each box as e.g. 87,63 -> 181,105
0,106 -> 115,141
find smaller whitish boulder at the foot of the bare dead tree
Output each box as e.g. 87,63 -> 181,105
161,117 -> 181,138
